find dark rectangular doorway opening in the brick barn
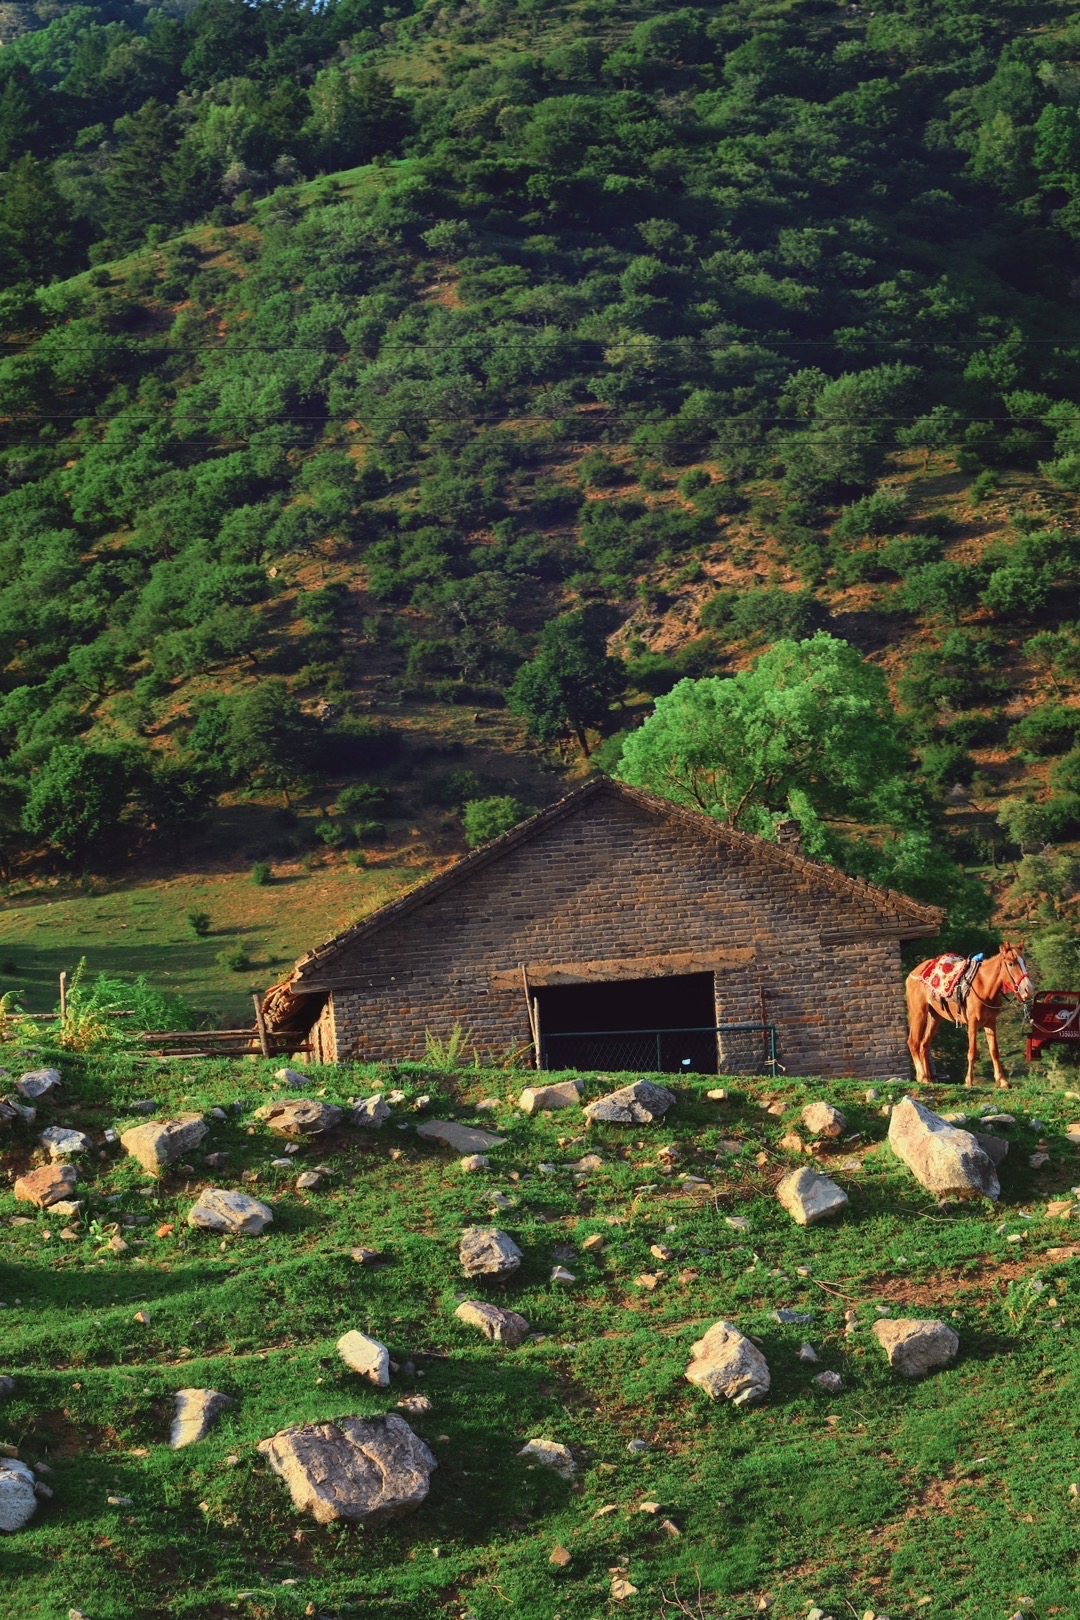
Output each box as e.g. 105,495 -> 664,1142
534,974 -> 717,1074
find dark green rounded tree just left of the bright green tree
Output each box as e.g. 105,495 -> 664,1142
507,612 -> 625,757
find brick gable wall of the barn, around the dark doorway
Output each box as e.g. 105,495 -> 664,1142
316,794 -> 908,1076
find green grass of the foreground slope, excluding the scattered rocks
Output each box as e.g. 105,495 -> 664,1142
0,1053 -> 1080,1620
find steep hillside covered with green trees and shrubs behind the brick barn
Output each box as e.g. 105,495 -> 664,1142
0,0 -> 1080,982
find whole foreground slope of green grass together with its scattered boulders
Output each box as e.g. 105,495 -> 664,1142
0,1051 -> 1080,1620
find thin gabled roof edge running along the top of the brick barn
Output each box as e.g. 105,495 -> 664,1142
278,776 -> 946,995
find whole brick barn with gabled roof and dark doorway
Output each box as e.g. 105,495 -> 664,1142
264,778 -> 944,1076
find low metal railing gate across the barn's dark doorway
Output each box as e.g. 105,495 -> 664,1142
539,1024 -> 777,1076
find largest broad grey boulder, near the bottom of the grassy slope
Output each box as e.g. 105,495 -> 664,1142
259,1413 -> 439,1524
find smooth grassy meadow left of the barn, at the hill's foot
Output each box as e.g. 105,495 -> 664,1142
0,863 -> 426,1027
